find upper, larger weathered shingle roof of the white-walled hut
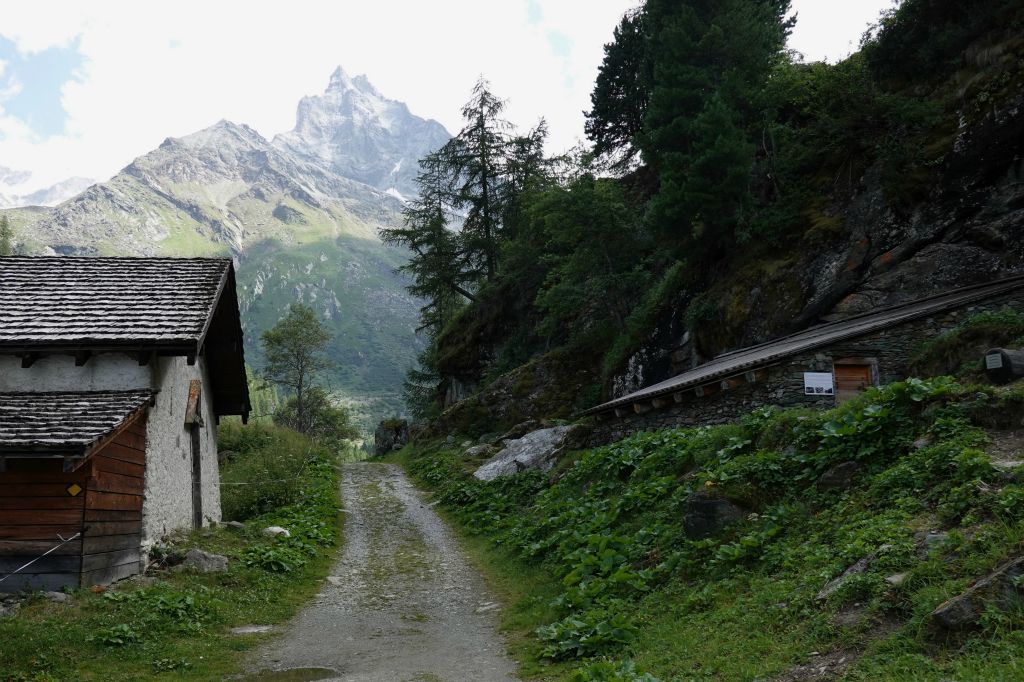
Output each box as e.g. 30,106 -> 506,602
0,257 -> 231,349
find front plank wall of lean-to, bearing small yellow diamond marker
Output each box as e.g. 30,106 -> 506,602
0,460 -> 89,592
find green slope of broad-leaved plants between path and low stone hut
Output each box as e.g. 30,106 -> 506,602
396,378 -> 1024,682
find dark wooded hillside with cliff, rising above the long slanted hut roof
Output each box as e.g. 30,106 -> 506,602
397,0 -> 1024,430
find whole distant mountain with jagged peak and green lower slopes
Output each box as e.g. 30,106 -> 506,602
7,70 -> 447,426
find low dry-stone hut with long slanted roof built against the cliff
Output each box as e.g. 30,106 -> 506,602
584,275 -> 1024,443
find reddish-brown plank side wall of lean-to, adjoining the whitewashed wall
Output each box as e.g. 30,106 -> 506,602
81,415 -> 145,587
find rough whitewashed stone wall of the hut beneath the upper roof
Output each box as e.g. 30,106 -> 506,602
0,353 -> 220,548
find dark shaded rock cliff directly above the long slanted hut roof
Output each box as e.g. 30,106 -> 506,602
609,87 -> 1024,397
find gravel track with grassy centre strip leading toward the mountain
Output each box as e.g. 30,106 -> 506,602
249,462 -> 516,682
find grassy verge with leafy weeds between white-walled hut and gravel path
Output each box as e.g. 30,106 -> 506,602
0,425 -> 342,682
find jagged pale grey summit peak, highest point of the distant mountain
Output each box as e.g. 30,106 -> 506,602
273,67 -> 451,198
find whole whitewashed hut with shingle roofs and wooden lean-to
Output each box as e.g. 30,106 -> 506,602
0,257 -> 250,592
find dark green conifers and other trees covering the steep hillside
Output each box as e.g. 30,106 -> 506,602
383,0 -> 1024,425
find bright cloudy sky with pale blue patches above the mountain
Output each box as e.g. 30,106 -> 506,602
0,0 -> 893,191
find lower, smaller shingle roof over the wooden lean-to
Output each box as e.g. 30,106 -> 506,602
0,390 -> 154,457
